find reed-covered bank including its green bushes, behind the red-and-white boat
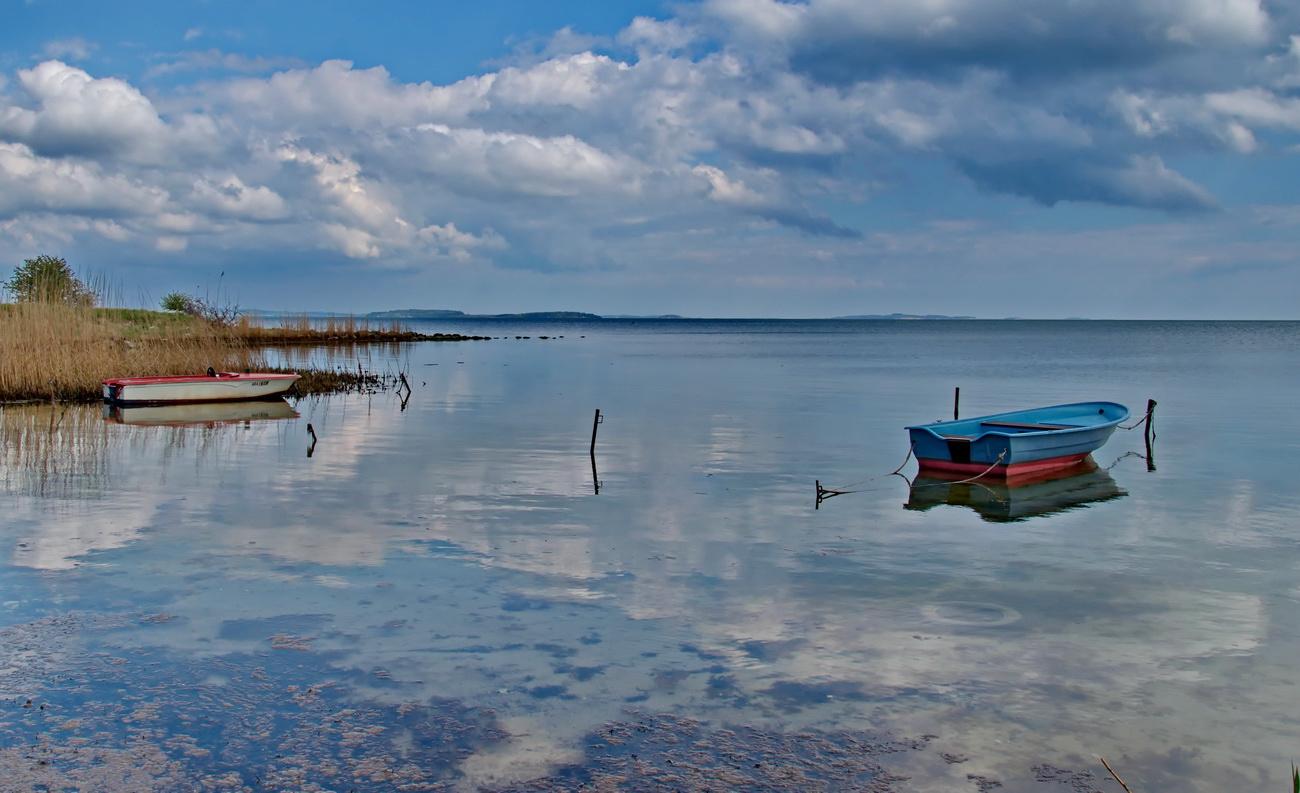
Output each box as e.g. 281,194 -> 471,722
0,256 -> 486,402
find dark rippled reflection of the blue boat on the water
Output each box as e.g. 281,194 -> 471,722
904,458 -> 1128,523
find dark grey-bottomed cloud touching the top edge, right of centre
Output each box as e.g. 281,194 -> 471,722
703,0 -> 1270,83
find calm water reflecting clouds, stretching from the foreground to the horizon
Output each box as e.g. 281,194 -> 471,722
0,320 -> 1300,792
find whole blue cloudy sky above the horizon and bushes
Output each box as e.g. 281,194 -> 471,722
0,0 -> 1300,320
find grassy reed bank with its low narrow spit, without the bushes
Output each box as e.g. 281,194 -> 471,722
0,303 -> 471,402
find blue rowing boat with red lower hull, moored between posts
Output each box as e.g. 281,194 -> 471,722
906,402 -> 1128,478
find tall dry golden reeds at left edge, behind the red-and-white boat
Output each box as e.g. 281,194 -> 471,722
0,303 -> 264,400
